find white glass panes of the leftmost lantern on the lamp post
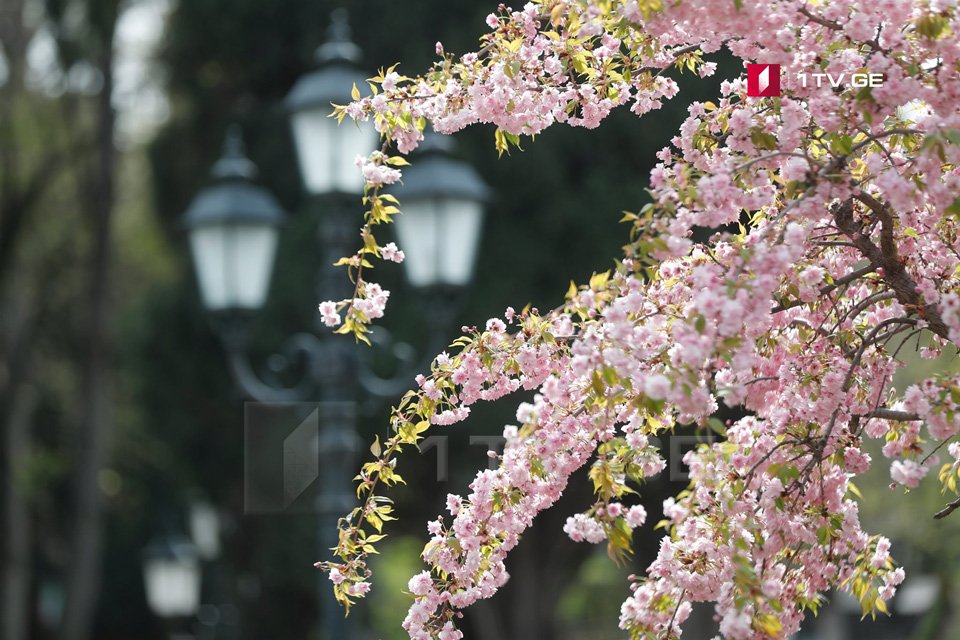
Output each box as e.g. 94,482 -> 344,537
190,221 -> 279,311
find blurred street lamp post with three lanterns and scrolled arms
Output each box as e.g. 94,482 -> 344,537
184,9 -> 488,640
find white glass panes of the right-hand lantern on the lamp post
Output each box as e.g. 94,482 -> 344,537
396,198 -> 483,287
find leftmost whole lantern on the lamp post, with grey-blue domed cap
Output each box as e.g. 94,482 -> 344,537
183,128 -> 284,311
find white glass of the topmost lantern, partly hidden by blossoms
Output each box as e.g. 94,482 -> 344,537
291,107 -> 377,194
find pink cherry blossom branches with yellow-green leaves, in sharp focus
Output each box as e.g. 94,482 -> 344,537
319,0 -> 960,640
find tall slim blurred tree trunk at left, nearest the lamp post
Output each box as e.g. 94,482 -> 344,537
61,35 -> 117,640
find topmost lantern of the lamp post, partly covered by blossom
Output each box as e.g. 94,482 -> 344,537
286,9 -> 377,194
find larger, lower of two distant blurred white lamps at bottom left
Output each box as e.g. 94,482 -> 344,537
143,541 -> 201,618
